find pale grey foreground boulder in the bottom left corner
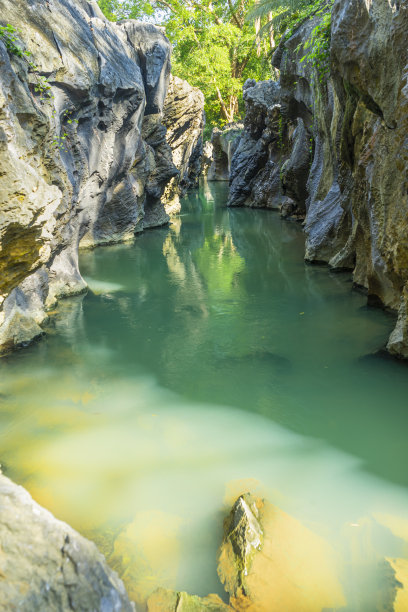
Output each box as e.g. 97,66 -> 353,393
0,475 -> 135,612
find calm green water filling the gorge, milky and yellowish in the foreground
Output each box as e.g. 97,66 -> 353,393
0,184 -> 408,612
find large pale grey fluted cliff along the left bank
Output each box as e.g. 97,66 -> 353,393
0,0 -> 182,350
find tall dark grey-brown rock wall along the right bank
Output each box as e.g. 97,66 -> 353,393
229,0 -> 408,358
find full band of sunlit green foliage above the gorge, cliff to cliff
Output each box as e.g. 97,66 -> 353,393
99,0 -> 326,131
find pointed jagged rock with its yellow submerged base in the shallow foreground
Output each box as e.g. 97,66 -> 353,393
218,493 -> 345,612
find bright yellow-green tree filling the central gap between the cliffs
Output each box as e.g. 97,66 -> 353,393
167,0 -> 271,125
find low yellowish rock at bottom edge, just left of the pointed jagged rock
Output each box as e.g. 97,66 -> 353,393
147,588 -> 233,612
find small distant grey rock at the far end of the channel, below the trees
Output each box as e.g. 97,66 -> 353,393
207,123 -> 244,181
